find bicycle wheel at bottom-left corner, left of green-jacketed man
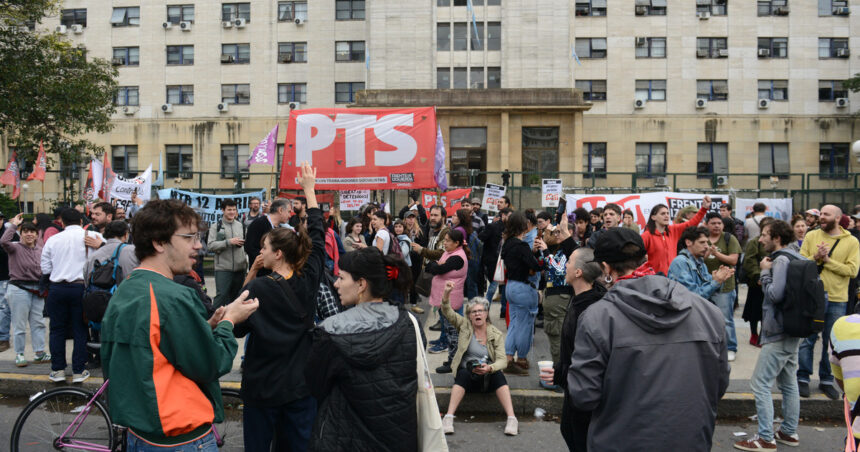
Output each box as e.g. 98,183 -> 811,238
11,388 -> 114,452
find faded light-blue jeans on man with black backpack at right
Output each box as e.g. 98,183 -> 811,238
750,337 -> 801,441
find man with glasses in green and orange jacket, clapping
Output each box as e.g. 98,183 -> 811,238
101,200 -> 258,452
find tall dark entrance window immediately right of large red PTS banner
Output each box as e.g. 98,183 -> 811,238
450,127 -> 487,187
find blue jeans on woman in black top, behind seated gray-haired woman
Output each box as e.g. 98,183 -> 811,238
505,281 -> 538,358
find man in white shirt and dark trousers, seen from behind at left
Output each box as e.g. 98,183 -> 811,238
41,208 -> 104,383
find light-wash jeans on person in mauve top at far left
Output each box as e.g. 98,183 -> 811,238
6,284 -> 45,355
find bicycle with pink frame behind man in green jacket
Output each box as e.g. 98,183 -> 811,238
10,380 -> 244,452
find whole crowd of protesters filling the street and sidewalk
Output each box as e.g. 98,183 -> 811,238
5,170 -> 860,451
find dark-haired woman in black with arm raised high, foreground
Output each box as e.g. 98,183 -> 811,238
233,164 -> 325,451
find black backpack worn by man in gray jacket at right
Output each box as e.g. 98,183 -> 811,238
772,249 -> 836,337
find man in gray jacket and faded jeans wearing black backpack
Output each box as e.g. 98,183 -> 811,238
735,220 -> 805,451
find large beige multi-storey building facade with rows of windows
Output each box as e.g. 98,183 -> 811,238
8,0 -> 860,207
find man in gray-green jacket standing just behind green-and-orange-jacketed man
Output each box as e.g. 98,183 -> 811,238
206,199 -> 248,308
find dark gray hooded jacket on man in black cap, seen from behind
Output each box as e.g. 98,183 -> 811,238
567,275 -> 730,452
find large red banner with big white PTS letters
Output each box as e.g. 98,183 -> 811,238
280,107 -> 437,190
